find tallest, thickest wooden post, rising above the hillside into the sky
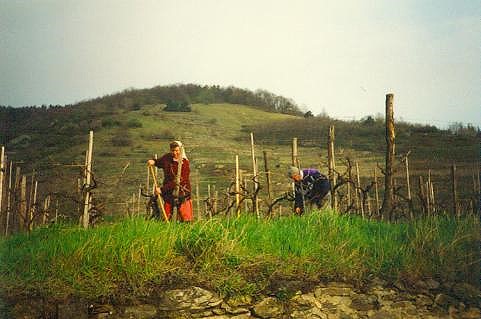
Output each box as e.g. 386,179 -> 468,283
381,93 -> 395,220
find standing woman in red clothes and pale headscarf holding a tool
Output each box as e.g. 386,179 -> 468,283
147,141 -> 193,222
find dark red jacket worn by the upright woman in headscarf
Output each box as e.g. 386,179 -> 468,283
155,153 -> 192,197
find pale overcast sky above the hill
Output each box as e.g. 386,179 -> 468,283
0,0 -> 481,127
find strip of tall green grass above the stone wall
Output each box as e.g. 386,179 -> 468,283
0,211 -> 480,298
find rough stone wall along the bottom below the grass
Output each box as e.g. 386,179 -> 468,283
4,279 -> 481,319
